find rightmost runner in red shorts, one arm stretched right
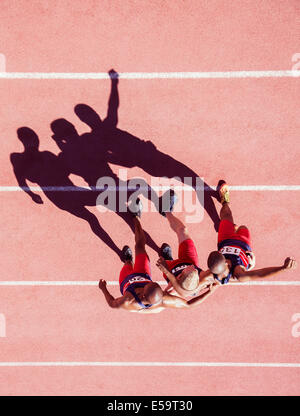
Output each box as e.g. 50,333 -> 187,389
207,181 -> 297,284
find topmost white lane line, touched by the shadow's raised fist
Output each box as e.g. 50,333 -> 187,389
0,70 -> 300,80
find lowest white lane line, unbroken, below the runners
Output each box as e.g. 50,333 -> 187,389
0,361 -> 300,368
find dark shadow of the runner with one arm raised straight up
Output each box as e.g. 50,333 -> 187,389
66,70 -> 220,231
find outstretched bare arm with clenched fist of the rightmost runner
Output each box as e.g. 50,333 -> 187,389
234,257 -> 297,282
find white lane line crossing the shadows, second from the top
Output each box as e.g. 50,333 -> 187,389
0,185 -> 300,192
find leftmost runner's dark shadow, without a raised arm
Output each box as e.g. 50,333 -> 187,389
10,127 -> 159,257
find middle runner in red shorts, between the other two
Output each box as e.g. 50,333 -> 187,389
156,189 -> 217,297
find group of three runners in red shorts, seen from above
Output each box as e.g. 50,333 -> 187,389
99,181 -> 296,313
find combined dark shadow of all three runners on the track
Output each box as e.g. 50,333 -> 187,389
11,70 -> 219,256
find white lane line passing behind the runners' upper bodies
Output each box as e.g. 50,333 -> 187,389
0,280 -> 300,287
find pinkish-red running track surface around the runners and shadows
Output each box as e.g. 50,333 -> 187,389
0,0 -> 300,395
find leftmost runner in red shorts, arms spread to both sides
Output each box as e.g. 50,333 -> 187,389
99,199 -> 215,313
